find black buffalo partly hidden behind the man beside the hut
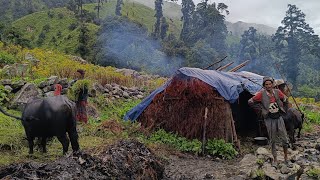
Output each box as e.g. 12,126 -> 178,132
282,108 -> 304,146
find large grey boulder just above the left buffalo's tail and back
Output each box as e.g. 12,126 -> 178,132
10,83 -> 39,110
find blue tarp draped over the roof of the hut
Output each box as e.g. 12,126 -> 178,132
124,67 -> 263,121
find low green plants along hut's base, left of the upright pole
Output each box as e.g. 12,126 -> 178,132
149,129 -> 201,154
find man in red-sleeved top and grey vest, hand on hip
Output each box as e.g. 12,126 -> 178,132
248,77 -> 289,164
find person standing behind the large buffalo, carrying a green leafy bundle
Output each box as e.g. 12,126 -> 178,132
75,69 -> 88,123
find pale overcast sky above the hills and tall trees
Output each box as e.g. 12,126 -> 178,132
175,0 -> 320,34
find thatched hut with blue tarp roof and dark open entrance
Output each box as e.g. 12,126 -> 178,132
124,67 -> 263,145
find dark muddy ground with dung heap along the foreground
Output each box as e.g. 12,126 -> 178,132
0,133 -> 320,180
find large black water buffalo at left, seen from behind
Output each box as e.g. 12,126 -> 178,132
0,96 -> 79,154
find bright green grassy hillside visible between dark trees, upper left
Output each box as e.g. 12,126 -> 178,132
12,0 -> 181,57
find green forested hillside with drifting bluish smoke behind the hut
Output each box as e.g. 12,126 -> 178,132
0,0 -> 320,99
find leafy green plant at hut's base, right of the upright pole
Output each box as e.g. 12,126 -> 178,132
206,139 -> 238,159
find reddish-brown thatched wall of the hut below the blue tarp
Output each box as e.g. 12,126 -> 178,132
138,75 -> 237,146
